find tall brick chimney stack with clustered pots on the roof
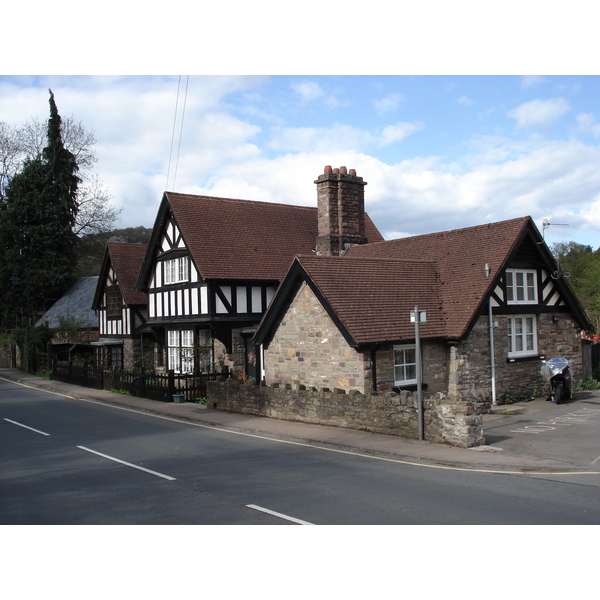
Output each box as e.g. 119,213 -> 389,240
315,166 -> 367,256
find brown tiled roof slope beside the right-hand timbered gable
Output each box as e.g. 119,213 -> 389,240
348,217 -> 535,338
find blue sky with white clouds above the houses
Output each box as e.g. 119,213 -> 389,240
0,75 -> 600,248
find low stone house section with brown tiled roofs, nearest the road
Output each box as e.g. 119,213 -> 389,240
255,204 -> 590,403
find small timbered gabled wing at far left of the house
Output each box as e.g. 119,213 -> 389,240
91,242 -> 157,369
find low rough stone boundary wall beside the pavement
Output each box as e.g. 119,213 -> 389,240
207,381 -> 485,448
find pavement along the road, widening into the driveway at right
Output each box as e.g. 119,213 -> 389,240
0,369 -> 600,474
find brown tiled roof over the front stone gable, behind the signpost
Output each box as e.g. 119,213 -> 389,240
298,256 -> 445,345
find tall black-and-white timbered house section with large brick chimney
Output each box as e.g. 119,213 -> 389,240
136,167 -> 383,380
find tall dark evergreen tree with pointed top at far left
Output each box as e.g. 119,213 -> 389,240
0,91 -> 79,326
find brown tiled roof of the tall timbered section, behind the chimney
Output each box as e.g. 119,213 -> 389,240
165,192 -> 383,281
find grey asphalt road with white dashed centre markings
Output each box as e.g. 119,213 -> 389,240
0,380 -> 600,525
